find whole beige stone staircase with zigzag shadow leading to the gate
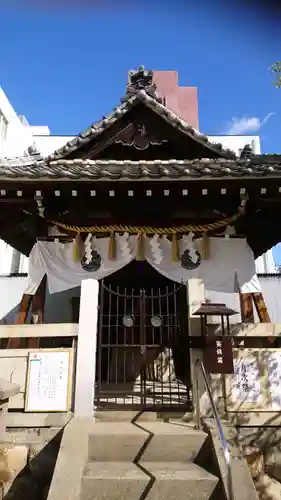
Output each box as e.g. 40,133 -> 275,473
80,417 -> 219,500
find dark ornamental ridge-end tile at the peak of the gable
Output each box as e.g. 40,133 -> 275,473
122,66 -> 165,104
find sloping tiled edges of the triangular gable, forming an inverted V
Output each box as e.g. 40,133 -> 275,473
48,89 -> 236,160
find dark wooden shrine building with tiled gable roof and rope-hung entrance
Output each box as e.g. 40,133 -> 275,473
0,67 -> 281,410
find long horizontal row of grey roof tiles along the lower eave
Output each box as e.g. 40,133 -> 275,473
0,155 -> 281,181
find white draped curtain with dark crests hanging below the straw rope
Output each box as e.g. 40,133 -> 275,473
26,234 -> 261,294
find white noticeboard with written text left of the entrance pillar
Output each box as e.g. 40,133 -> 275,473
25,349 -> 71,412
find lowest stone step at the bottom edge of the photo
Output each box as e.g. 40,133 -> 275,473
81,462 -> 218,500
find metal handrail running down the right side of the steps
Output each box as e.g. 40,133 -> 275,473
194,359 -> 234,500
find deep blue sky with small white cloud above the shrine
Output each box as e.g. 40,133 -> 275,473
0,0 -> 281,262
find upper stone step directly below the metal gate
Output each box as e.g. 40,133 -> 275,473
89,422 -> 207,462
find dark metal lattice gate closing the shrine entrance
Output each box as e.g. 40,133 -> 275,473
95,282 -> 191,411
